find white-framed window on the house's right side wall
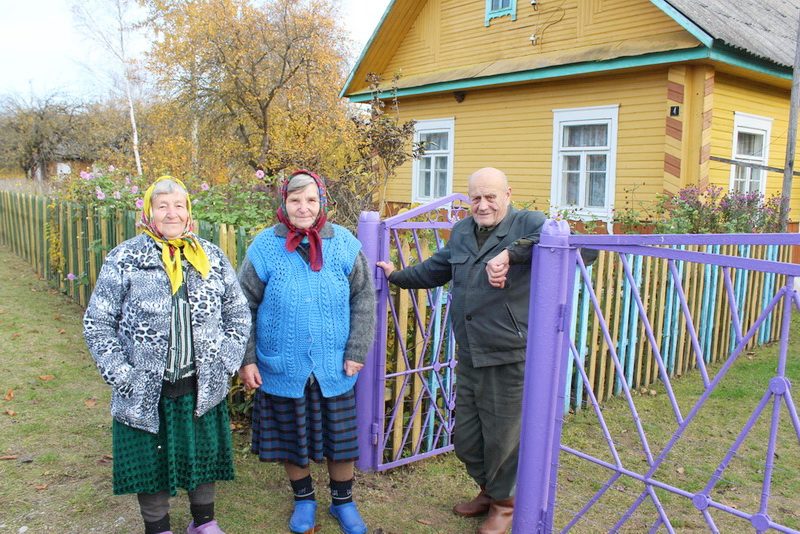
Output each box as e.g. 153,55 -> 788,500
730,112 -> 772,194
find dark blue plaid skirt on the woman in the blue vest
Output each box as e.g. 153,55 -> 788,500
251,380 -> 358,467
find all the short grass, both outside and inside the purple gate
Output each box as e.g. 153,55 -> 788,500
0,247 -> 800,534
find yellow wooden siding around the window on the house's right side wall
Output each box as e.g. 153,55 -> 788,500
710,72 -> 800,202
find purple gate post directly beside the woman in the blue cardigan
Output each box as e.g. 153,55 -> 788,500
356,211 -> 389,471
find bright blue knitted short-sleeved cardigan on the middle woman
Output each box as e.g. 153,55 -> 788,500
247,225 -> 361,398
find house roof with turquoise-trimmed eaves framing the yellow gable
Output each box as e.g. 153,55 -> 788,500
341,0 -> 800,101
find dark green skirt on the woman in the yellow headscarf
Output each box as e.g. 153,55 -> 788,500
113,393 -> 233,496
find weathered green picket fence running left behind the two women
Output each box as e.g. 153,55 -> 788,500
0,191 -> 258,307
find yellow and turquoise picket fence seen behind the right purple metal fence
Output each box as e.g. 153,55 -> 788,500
564,245 -> 791,412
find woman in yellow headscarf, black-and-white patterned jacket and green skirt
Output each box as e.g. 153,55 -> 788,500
84,177 -> 251,534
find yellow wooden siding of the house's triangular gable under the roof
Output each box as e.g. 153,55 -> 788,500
378,0 -> 697,90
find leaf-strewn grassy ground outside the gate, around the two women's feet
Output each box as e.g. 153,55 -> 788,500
0,245 -> 478,534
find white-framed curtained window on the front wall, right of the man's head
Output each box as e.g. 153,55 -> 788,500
551,106 -> 618,217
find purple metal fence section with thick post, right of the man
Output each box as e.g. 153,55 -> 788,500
513,221 -> 800,534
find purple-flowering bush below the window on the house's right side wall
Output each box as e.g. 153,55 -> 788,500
653,186 -> 789,234
